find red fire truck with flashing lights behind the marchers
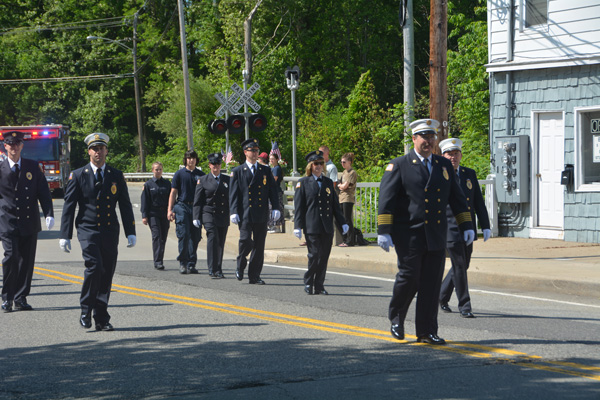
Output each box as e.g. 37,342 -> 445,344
0,125 -> 71,195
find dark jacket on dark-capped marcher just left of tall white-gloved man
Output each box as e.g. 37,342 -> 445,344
193,173 -> 230,226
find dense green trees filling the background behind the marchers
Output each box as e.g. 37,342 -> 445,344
0,0 -> 489,181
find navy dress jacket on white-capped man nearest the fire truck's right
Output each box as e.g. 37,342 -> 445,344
60,164 -> 135,239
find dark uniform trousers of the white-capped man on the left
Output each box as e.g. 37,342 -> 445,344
77,225 -> 119,323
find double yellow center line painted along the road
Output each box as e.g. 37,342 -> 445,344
35,267 -> 600,381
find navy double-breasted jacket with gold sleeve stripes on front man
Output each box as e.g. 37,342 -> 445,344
377,150 -> 473,251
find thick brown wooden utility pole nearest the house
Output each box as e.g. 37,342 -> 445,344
429,0 -> 448,148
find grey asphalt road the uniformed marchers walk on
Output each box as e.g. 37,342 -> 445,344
0,185 -> 600,399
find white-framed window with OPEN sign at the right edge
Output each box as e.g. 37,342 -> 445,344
575,106 -> 600,192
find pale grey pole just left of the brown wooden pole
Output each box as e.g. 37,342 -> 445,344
401,0 -> 415,154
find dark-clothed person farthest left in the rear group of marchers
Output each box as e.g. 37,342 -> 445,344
141,161 -> 171,270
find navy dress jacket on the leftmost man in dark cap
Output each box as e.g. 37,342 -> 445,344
0,158 -> 54,236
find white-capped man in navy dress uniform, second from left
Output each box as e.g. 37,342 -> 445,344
59,133 -> 136,331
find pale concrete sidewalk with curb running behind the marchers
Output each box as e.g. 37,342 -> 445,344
226,225 -> 600,298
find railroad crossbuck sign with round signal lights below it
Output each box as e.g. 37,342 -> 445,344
208,82 -> 267,135
